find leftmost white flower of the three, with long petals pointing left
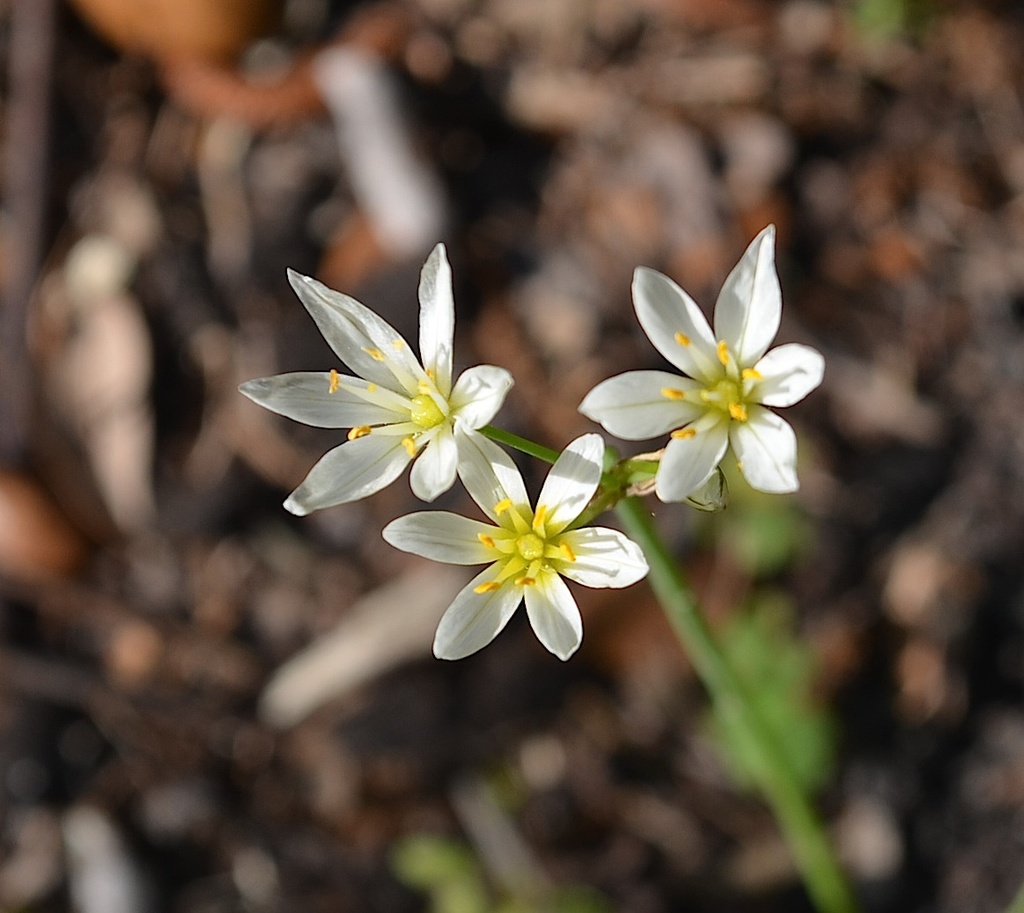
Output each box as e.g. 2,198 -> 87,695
239,245 -> 512,516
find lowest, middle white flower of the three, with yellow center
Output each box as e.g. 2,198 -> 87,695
383,433 -> 647,659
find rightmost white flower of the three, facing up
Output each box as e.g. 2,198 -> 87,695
580,225 -> 824,502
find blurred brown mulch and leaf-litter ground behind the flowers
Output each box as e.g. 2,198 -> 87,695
0,0 -> 1024,913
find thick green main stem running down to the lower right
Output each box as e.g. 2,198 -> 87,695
615,497 -> 864,913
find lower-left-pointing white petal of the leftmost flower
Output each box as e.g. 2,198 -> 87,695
285,434 -> 411,517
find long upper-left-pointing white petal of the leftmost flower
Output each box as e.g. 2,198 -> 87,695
288,269 -> 424,395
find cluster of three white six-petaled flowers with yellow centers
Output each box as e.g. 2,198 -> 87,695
241,226 -> 824,659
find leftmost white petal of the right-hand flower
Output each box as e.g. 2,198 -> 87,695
580,371 -> 703,441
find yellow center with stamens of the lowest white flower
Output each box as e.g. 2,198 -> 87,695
475,498 -> 577,594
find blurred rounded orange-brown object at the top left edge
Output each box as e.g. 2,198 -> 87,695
71,0 -> 283,62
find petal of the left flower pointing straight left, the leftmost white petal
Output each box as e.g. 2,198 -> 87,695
239,372 -> 399,428
